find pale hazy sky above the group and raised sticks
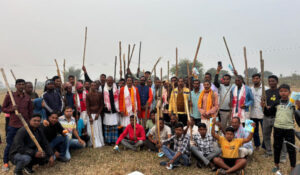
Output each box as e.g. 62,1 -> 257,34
0,0 -> 300,81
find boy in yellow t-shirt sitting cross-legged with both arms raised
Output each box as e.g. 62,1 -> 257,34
211,118 -> 255,175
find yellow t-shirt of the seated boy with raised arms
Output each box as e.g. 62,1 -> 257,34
219,136 -> 244,159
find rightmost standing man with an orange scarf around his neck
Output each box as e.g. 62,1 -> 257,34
198,81 -> 219,132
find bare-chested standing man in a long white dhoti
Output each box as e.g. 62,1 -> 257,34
86,82 -> 104,148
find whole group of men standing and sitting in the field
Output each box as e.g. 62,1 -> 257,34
2,66 -> 300,174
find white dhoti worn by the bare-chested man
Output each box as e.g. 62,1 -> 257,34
87,114 -> 104,148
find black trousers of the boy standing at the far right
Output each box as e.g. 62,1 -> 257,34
273,127 -> 296,167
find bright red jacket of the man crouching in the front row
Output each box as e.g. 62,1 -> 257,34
116,124 -> 146,145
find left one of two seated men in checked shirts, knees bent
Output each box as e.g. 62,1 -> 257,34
158,123 -> 190,169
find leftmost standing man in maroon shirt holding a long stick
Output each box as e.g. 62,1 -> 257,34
2,79 -> 33,171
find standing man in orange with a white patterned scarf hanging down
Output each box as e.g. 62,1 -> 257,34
119,77 -> 141,127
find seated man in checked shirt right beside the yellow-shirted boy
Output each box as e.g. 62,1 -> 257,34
191,123 -> 221,170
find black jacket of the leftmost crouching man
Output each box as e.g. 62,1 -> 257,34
9,127 -> 54,161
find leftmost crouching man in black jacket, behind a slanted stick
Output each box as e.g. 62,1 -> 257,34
9,114 -> 54,175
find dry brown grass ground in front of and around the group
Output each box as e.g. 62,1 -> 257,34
0,90 -> 300,175
